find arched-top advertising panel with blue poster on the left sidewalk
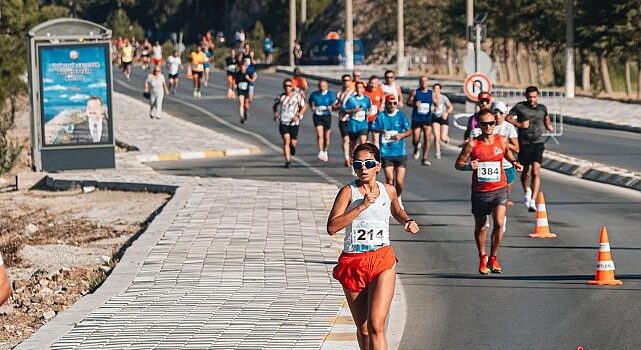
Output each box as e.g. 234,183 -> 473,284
27,18 -> 115,171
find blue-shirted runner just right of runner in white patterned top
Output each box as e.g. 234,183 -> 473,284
309,79 -> 338,162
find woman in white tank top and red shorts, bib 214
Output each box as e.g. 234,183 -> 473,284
327,143 -> 419,349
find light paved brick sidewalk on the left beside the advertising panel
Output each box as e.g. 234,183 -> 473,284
16,90 -> 382,350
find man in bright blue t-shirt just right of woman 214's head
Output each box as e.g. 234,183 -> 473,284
372,95 -> 412,205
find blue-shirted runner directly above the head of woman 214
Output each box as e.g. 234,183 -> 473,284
343,81 -> 372,169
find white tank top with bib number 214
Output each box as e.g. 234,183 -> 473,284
343,181 -> 392,253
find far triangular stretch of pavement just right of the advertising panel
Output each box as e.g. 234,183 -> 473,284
113,92 -> 260,162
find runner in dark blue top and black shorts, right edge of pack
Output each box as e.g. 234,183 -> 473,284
407,76 -> 434,166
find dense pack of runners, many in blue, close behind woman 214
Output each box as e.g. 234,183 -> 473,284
274,68 -> 454,205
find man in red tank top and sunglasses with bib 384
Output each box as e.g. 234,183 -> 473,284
455,109 -> 523,275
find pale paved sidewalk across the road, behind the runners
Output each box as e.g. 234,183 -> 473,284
277,66 -> 641,133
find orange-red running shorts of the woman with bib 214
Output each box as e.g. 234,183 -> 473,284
332,245 -> 398,293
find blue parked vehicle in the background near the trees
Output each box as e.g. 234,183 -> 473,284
300,39 -> 365,65
